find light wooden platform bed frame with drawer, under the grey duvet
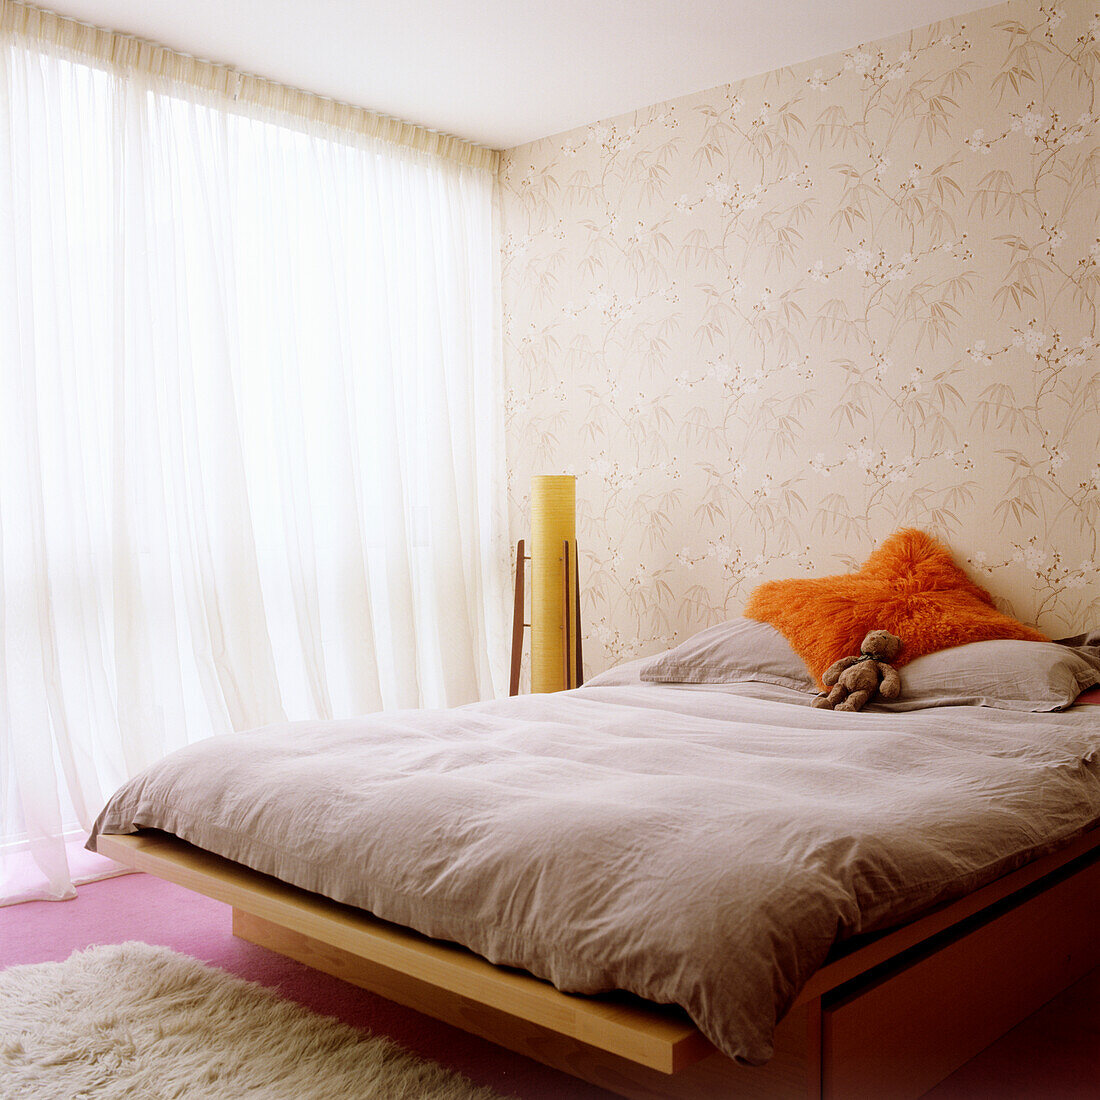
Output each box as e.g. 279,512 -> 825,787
97,828 -> 1100,1100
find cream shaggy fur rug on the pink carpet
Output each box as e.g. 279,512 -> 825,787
0,943 -> 499,1100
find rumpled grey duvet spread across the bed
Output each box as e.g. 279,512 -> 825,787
89,673 -> 1100,1064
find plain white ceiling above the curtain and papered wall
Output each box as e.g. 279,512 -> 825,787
39,0 -> 988,149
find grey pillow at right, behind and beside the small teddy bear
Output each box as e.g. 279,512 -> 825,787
876,641 -> 1100,712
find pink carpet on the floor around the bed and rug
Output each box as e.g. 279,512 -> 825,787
0,875 -> 1100,1100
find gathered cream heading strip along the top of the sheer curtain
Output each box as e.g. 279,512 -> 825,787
0,0 -> 499,172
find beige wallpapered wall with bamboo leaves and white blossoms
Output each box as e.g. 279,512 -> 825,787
501,0 -> 1100,674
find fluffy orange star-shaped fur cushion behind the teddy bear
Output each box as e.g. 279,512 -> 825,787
745,528 -> 1051,683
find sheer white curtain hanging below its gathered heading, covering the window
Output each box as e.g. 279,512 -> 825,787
0,21 -> 507,898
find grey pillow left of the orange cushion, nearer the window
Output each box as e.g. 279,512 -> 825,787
641,618 -> 814,691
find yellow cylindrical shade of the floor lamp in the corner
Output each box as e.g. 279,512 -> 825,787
531,474 -> 580,692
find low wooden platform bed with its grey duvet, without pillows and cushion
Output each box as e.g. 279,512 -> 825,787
90,624 -> 1100,1097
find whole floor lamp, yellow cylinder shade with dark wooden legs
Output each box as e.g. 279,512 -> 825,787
508,474 -> 584,695
